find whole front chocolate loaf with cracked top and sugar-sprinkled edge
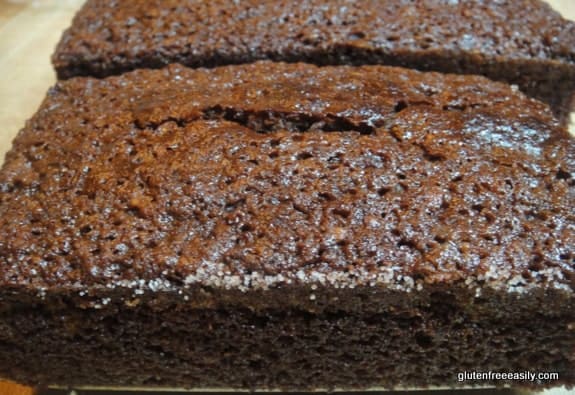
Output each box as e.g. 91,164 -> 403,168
0,62 -> 575,389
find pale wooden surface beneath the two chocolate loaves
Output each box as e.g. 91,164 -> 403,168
0,0 -> 575,395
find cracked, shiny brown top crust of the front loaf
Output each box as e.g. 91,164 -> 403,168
0,62 -> 575,292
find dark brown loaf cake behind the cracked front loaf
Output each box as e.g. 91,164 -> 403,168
53,0 -> 575,122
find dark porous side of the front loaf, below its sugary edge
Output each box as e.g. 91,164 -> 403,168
0,289 -> 575,390
